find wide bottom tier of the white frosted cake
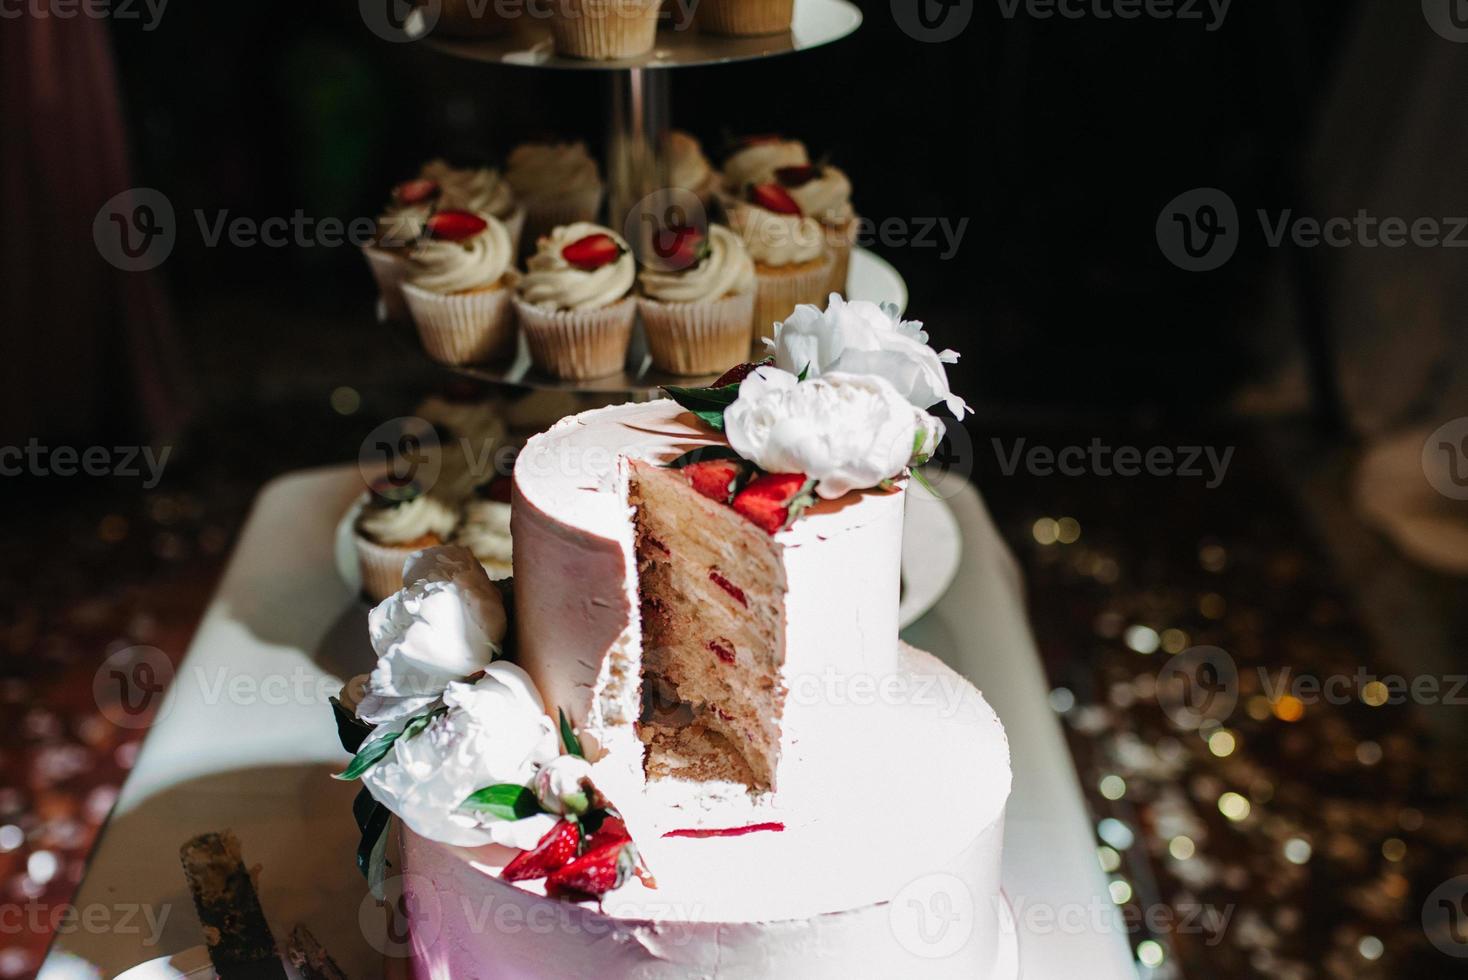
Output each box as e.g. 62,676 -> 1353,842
404,647 -> 1010,979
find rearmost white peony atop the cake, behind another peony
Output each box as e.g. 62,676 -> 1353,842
766,293 -> 973,420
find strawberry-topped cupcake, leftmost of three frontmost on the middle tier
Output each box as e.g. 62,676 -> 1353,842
402,210 -> 515,364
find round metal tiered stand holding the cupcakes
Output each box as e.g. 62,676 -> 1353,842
405,0 -> 907,390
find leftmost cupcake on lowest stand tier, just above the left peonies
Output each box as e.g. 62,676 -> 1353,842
354,480 -> 458,603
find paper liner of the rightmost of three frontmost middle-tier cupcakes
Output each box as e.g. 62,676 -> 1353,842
637,290 -> 755,374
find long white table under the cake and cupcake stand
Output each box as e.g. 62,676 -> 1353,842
41,467 -> 1136,980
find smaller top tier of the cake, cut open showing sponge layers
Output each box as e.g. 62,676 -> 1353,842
512,401 -> 903,822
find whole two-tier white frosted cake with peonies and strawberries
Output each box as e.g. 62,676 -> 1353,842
336,298 -> 1013,980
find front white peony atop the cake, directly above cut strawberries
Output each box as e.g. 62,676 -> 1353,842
724,367 -> 937,499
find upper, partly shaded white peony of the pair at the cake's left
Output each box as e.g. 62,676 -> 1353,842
357,546 -> 506,725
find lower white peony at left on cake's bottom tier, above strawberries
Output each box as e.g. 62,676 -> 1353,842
363,663 -> 559,849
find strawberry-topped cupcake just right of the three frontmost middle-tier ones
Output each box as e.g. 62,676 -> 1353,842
730,183 -> 834,340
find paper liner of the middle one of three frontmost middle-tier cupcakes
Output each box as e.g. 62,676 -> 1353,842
515,296 -> 637,381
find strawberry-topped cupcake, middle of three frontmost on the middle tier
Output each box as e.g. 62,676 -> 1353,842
515,222 -> 637,380
